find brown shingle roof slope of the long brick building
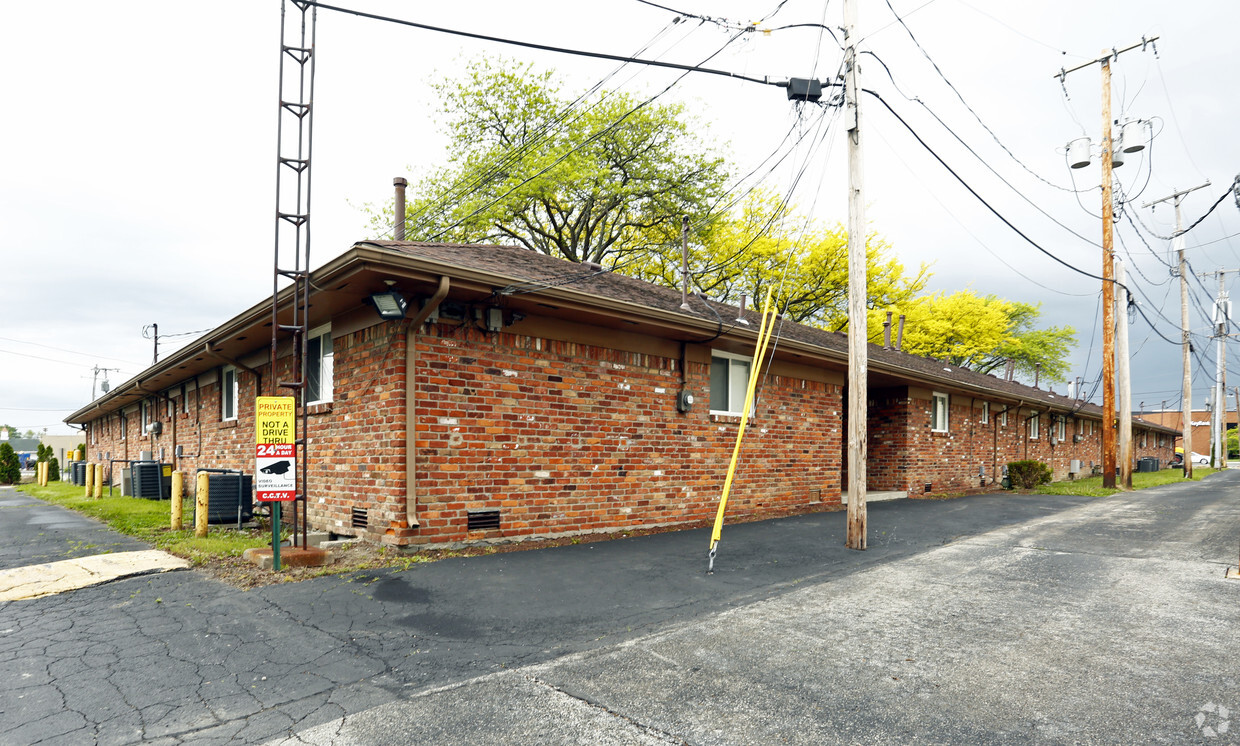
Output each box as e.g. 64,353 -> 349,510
367,240 -> 1174,432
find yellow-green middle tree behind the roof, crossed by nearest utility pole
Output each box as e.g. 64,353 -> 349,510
626,193 -> 930,330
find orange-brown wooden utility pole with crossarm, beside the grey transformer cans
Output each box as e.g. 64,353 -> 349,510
1055,36 -> 1158,488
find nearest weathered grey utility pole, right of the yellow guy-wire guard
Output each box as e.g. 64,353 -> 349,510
843,0 -> 869,549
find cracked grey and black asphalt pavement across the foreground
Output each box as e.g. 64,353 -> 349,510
0,472 -> 1240,745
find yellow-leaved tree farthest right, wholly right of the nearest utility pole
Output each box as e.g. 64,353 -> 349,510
869,290 -> 1076,380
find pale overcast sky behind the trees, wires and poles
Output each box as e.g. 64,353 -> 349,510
0,0 -> 1240,434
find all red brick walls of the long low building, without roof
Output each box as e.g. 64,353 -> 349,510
77,314 -> 1172,544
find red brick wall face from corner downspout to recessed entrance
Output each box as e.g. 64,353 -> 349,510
412,327 -> 841,543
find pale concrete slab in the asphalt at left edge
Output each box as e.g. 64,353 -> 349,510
0,549 -> 190,601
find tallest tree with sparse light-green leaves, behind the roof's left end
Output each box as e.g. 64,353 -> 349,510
368,58 -> 727,266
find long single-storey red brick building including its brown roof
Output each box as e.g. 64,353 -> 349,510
67,242 -> 1174,545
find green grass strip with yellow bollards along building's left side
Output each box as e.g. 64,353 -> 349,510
19,482 -> 270,564
